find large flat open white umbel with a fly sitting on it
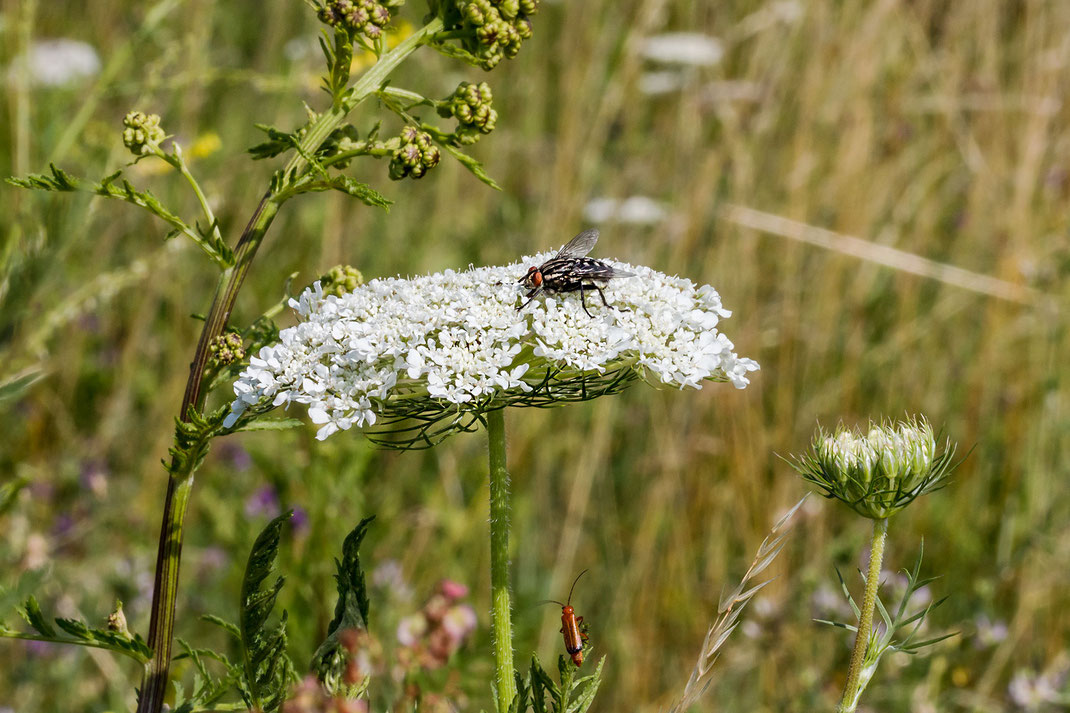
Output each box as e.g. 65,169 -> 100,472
225,253 -> 759,439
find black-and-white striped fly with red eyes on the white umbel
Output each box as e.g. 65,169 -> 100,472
517,229 -> 636,319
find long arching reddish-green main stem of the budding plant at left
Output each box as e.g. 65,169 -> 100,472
137,19 -> 442,713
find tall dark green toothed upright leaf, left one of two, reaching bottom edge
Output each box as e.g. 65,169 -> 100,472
240,511 -> 296,713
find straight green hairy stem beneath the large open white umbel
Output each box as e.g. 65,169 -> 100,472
487,409 -> 517,713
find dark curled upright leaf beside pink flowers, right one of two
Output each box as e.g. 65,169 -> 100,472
311,516 -> 376,693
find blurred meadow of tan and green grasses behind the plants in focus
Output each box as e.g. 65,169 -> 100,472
0,0 -> 1070,713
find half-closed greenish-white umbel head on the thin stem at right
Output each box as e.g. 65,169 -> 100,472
792,418 -> 954,520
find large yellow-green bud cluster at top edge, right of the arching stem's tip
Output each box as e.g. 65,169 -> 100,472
455,0 -> 538,70
